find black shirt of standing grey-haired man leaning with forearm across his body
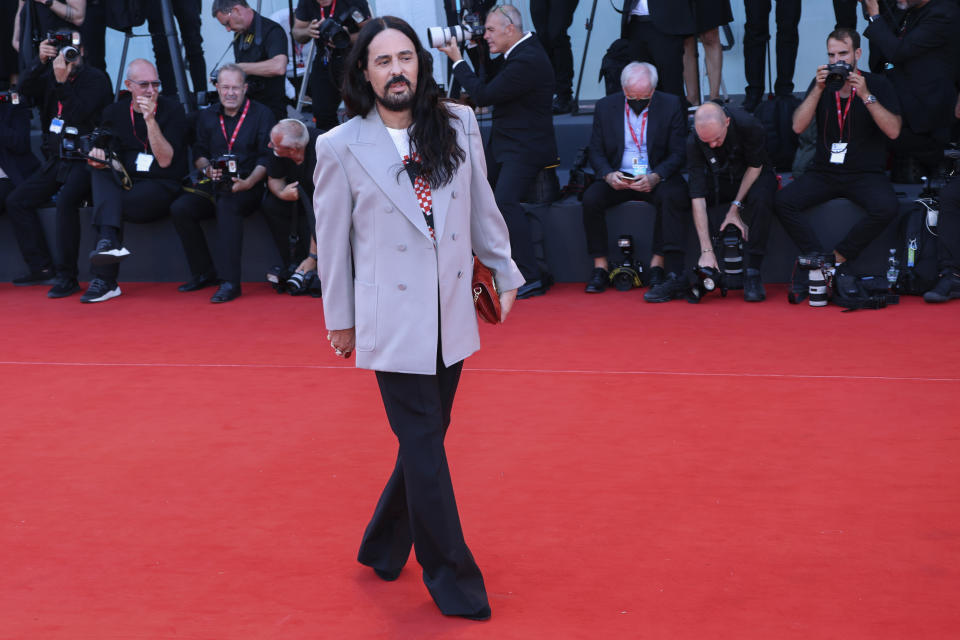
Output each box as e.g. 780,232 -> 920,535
233,13 -> 290,119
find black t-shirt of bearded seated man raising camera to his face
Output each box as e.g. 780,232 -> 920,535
807,71 -> 900,173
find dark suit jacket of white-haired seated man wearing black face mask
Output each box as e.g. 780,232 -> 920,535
590,91 -> 687,180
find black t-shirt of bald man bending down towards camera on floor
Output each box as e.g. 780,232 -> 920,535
687,107 -> 770,198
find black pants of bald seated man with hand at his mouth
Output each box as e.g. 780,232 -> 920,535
89,168 -> 181,284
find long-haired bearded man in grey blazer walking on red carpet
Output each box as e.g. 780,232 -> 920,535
313,17 -> 523,620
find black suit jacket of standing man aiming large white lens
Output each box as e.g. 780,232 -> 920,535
453,33 -> 557,166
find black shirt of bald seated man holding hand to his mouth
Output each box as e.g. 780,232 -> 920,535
100,96 -> 187,180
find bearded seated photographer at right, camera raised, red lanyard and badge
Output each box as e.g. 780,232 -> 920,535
775,29 -> 900,302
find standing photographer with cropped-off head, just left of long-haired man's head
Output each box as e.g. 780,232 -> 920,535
293,0 -> 371,131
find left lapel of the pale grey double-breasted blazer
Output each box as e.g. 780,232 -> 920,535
349,108 -> 430,238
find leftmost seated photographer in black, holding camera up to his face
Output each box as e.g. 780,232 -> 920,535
7,34 -> 113,298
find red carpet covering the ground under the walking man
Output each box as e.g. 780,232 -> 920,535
0,283 -> 960,640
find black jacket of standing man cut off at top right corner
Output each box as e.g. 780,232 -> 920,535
863,0 -> 960,133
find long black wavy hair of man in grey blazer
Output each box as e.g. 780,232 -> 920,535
341,16 -> 467,188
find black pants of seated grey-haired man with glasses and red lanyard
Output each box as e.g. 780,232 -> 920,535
170,183 -> 263,286
